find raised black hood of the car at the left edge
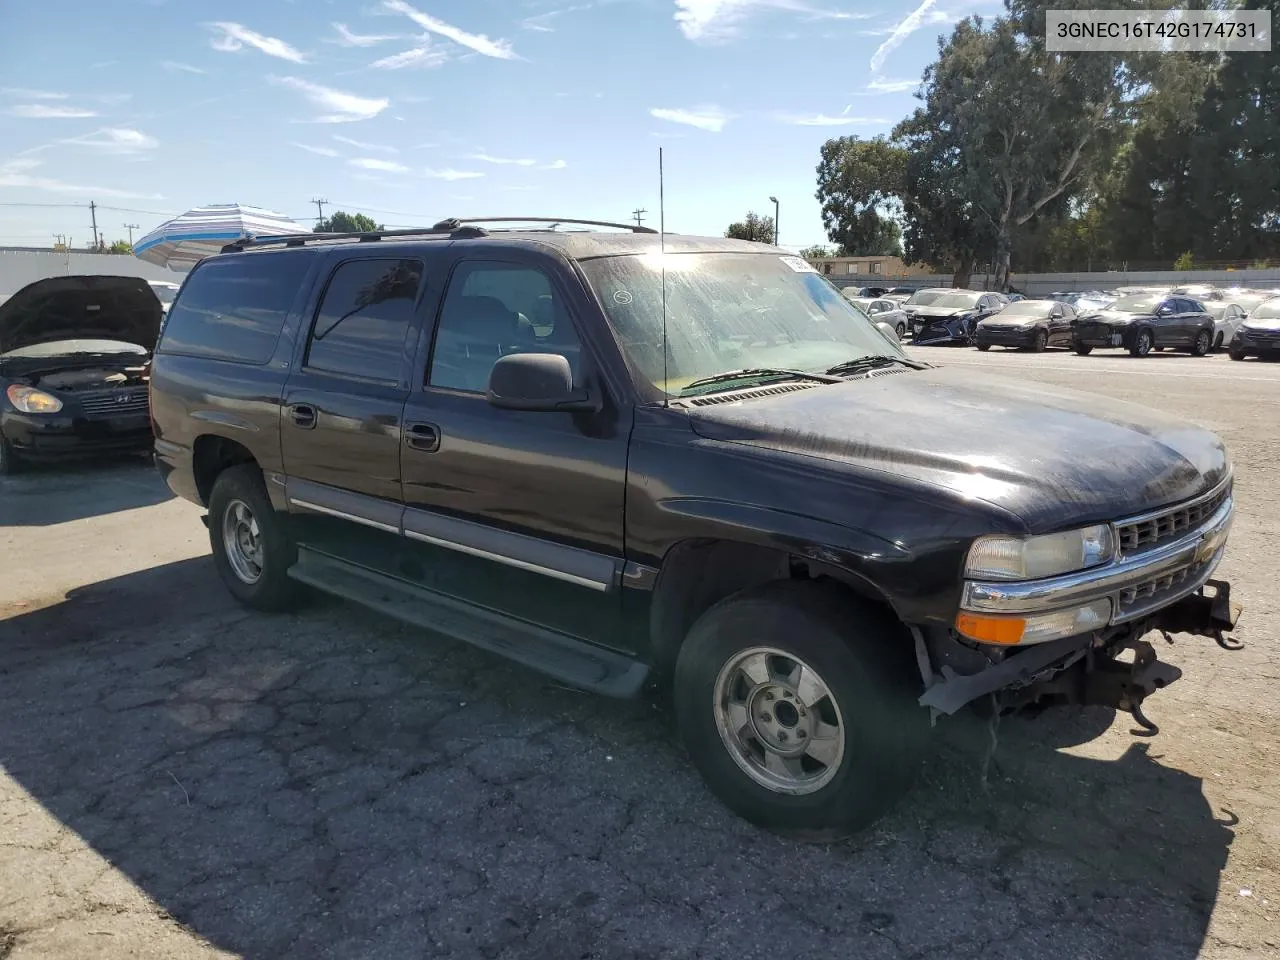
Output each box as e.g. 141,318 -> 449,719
0,276 -> 163,353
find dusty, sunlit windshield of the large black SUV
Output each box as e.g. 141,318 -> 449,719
582,253 -> 904,394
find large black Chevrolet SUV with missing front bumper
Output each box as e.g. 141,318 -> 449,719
151,220 -> 1238,836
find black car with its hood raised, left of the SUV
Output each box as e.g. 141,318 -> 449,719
0,276 -> 161,474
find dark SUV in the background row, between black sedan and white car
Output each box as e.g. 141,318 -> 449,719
1071,293 -> 1213,357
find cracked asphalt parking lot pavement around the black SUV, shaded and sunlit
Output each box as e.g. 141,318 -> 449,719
0,349 -> 1280,960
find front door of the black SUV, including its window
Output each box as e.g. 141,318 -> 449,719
403,251 -> 635,650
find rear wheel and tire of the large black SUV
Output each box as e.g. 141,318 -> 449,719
209,463 -> 297,611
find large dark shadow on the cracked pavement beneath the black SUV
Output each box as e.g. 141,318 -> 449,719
0,558 -> 1233,960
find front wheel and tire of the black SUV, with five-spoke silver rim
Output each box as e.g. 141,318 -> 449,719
673,581 -> 929,841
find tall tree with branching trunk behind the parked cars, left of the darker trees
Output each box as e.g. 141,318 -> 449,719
895,12 -> 1129,289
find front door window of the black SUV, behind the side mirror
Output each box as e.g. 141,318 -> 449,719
428,262 -> 582,393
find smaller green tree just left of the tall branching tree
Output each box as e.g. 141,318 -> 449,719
815,137 -> 908,256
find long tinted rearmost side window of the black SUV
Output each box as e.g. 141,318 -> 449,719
159,251 -> 311,364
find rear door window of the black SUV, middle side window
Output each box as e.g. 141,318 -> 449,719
306,260 -> 422,383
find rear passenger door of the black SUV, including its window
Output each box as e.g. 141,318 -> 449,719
280,251 -> 425,566
